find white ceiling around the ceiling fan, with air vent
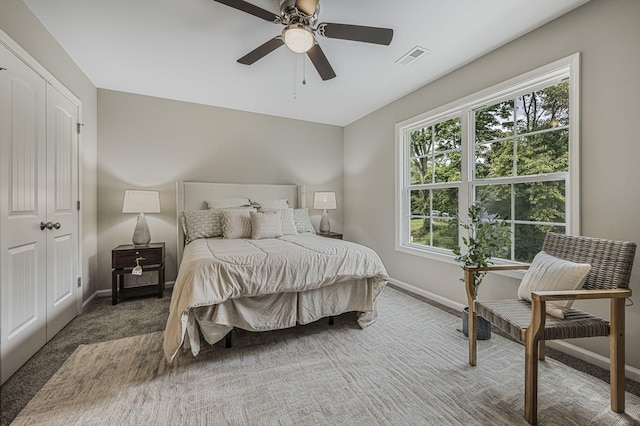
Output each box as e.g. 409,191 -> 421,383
24,0 -> 588,126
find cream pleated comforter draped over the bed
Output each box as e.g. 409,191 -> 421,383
164,234 -> 389,362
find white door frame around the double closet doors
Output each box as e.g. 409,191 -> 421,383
0,29 -> 86,315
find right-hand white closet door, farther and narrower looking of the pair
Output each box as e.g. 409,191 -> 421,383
46,85 -> 79,341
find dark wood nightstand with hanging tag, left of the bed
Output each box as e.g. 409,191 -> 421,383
111,243 -> 164,305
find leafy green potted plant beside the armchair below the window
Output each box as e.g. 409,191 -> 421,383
453,197 -> 511,340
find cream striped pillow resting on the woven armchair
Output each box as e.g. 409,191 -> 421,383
518,251 -> 591,318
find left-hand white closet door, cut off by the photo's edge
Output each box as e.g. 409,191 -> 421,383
0,45 -> 48,383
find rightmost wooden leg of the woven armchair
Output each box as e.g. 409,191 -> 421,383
609,299 -> 625,413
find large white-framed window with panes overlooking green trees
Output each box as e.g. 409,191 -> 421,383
396,54 -> 579,262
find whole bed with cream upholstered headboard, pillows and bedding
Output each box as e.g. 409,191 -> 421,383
164,182 -> 389,362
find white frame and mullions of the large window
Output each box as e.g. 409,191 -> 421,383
395,53 -> 580,263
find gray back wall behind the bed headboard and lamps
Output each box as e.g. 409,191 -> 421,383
98,89 -> 343,289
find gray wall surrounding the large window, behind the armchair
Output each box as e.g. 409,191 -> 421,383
344,0 -> 640,372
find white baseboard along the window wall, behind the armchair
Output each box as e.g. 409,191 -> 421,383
389,278 -> 640,382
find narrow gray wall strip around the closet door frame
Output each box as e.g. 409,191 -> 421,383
0,0 -> 98,299
